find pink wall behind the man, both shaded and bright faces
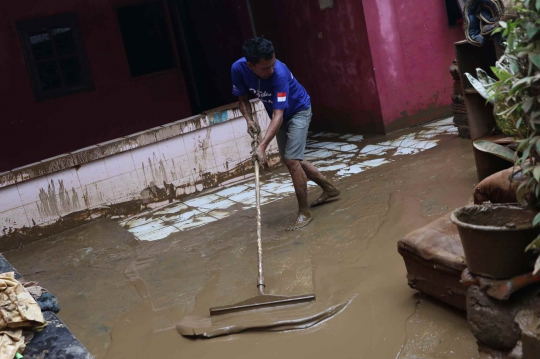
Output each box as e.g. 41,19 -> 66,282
275,0 -> 464,133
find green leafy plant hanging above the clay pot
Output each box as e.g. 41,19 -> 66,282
480,0 -> 540,274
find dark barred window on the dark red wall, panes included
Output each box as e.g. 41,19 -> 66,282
17,13 -> 93,101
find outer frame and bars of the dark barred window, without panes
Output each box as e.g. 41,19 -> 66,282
16,12 -> 94,102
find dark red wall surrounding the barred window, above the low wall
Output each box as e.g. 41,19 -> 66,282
0,0 -> 191,171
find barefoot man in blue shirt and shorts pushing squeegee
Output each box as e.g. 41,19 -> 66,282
231,37 -> 340,231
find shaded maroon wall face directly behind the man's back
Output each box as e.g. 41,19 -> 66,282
275,0 -> 384,133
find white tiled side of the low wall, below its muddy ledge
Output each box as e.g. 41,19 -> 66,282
0,103 -> 277,237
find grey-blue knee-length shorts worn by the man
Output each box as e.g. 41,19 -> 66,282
276,107 -> 313,161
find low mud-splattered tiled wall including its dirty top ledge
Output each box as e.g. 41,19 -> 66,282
0,101 -> 279,250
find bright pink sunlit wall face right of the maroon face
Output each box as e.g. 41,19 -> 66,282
362,0 -> 464,132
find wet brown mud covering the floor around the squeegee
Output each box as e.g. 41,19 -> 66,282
5,130 -> 477,359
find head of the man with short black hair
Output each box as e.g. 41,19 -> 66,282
242,37 -> 276,80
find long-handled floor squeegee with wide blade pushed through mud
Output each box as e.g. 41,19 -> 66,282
210,146 -> 315,316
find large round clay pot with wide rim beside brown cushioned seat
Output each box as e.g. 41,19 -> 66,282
451,204 -> 540,279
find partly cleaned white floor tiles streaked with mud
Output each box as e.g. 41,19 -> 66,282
119,118 -> 457,241
